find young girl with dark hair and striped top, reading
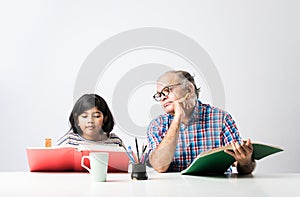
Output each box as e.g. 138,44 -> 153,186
57,94 -> 122,146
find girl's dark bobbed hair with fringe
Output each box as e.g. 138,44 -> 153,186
69,94 -> 115,135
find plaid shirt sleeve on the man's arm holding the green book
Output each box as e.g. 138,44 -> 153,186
222,113 -> 242,145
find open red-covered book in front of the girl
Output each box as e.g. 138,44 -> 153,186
26,144 -> 129,172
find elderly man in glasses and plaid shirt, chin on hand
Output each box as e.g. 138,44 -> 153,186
147,71 -> 255,174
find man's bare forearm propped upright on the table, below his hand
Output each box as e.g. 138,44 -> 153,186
149,119 -> 180,172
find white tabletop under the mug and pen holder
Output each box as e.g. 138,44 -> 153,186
0,171 -> 300,197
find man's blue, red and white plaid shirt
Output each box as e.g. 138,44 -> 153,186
147,101 -> 242,172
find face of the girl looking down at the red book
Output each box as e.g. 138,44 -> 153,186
78,107 -> 106,140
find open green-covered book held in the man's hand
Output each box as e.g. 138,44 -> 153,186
181,143 -> 283,175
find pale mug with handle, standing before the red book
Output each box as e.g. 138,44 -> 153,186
81,152 -> 108,182
